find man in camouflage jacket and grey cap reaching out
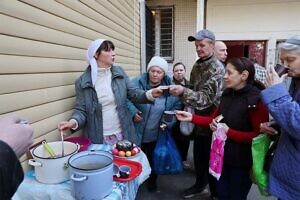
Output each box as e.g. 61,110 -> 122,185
170,29 -> 225,198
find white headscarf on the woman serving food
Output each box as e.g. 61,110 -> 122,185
86,39 -> 105,85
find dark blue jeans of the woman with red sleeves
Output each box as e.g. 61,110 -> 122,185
217,164 -> 252,200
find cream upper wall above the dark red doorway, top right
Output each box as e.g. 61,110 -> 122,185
206,0 -> 300,65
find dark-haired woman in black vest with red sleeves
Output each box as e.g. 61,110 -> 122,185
176,58 -> 268,200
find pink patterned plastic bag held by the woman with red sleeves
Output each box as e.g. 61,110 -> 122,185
209,124 -> 227,180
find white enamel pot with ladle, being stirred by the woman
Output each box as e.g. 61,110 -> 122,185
28,141 -> 80,184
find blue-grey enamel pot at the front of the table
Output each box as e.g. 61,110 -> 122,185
68,151 -> 113,200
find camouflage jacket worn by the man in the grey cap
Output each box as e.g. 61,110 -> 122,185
182,56 -> 225,135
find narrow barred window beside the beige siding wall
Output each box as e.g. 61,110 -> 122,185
151,7 -> 174,61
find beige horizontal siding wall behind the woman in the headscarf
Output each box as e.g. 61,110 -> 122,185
0,0 -> 140,169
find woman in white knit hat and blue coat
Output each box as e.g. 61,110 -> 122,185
128,56 -> 181,191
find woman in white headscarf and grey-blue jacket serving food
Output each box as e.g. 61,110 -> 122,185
58,39 -> 162,144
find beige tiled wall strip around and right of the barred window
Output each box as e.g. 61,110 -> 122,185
146,0 -> 197,75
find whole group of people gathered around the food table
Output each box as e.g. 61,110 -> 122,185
0,29 -> 300,200
